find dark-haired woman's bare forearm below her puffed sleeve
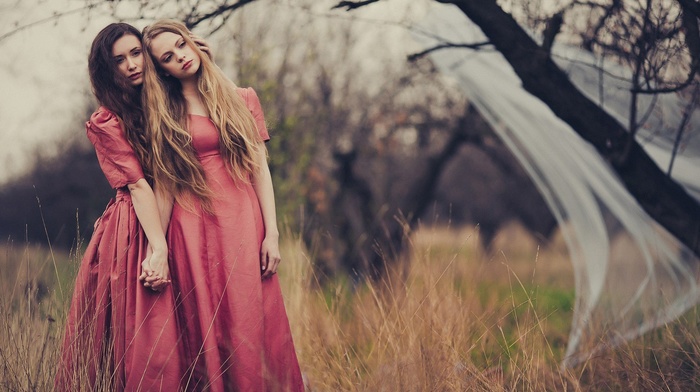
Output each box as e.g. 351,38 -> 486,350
129,178 -> 167,250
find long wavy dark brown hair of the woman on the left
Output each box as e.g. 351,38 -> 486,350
88,23 -> 151,179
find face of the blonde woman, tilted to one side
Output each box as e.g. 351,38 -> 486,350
150,32 -> 201,80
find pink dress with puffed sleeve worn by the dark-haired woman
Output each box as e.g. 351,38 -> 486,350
55,107 -> 183,391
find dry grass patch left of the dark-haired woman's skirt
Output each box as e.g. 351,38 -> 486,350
0,240 -> 75,391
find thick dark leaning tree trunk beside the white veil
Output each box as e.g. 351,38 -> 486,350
440,0 -> 700,255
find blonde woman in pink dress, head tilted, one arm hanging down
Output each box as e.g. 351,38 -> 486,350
143,21 -> 303,391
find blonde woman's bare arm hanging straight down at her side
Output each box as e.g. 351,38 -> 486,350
253,147 -> 281,278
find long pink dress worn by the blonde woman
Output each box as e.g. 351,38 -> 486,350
168,88 -> 304,391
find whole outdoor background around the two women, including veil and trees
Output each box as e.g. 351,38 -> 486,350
0,0 -> 700,390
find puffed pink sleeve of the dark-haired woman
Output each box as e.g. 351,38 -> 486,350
85,107 -> 144,189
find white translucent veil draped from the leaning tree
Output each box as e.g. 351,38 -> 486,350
415,5 -> 700,366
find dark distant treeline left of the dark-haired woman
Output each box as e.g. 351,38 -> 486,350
0,137 -> 114,249
